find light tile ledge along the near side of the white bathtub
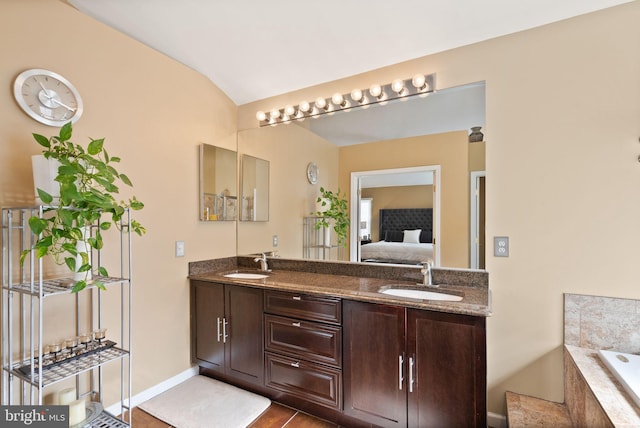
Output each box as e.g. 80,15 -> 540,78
564,344 -> 640,427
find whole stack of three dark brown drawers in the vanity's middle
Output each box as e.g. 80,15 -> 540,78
264,291 -> 342,410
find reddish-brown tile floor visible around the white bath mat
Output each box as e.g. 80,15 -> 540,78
131,403 -> 338,428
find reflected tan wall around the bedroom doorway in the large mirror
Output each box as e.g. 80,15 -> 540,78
340,131 -> 469,267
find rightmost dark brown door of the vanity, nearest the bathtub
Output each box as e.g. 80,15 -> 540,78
407,309 -> 487,428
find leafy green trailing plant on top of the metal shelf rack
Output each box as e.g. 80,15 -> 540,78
20,122 -> 146,293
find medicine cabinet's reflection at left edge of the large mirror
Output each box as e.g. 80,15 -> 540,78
240,154 -> 269,221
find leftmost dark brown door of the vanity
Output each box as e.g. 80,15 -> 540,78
192,281 -> 224,372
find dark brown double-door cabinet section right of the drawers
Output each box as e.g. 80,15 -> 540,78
343,301 -> 486,427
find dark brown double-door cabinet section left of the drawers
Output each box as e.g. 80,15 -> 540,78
191,281 -> 264,384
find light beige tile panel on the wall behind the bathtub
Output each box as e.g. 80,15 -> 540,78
564,294 -> 640,354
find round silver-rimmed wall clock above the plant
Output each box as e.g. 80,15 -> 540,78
13,68 -> 82,126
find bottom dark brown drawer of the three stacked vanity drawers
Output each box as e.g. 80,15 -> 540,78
265,352 -> 342,410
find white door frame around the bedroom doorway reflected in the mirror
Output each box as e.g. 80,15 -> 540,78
349,165 -> 441,266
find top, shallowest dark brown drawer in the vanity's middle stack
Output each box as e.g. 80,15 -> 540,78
264,291 -> 342,324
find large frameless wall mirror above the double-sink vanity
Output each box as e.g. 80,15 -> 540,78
238,82 -> 485,268
